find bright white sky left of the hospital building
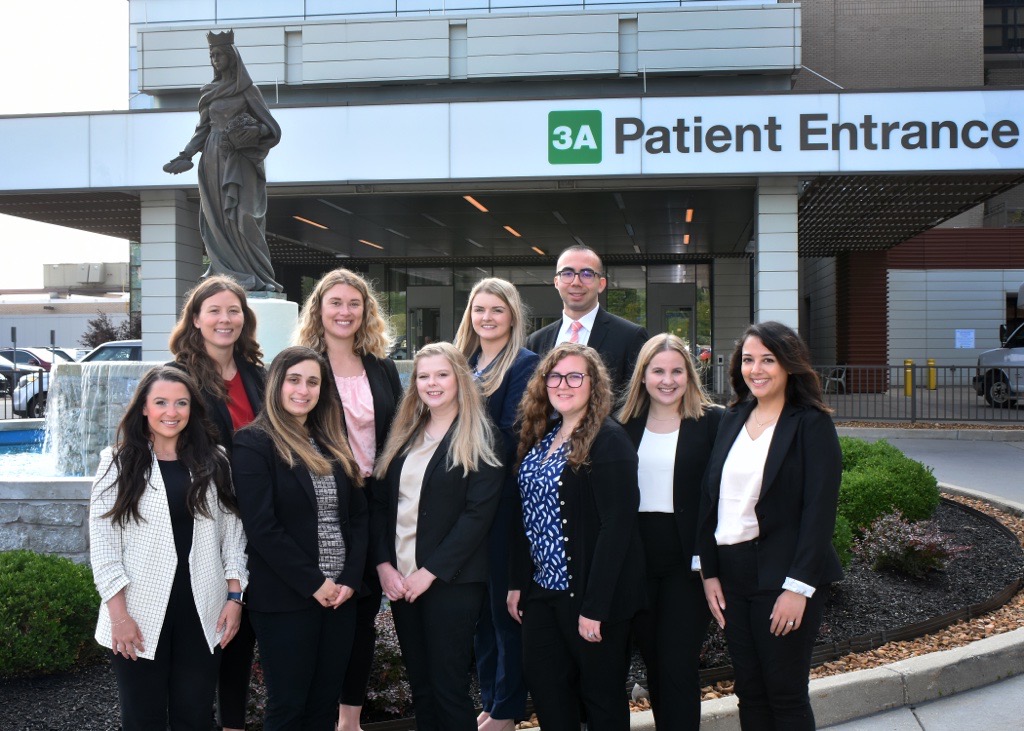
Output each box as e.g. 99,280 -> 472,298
0,0 -> 129,292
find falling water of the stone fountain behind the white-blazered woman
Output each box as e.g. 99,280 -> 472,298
43,361 -> 157,476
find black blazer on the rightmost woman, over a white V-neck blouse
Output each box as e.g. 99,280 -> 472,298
697,400 -> 843,591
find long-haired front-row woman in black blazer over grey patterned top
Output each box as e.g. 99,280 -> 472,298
231,347 -> 368,731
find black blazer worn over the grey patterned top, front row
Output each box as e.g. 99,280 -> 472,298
231,427 -> 369,612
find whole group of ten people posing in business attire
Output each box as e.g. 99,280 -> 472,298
90,241 -> 841,731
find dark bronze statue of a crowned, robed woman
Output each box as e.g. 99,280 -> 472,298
164,31 -> 284,292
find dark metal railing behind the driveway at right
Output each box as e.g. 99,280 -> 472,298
706,363 -> 1024,424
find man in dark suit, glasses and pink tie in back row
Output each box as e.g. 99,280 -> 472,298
526,245 -> 647,393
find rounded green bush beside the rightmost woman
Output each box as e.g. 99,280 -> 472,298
839,438 -> 939,532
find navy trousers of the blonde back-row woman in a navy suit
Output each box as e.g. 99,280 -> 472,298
474,490 -> 526,720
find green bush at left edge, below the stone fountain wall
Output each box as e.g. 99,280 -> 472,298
0,551 -> 100,678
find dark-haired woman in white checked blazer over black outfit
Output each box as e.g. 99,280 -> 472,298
89,367 -> 248,731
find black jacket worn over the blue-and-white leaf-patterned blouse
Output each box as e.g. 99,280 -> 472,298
509,419 -> 646,621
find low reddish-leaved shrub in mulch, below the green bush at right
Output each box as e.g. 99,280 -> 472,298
854,511 -> 967,578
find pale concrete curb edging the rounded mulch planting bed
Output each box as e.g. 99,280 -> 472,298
630,481 -> 1024,731
